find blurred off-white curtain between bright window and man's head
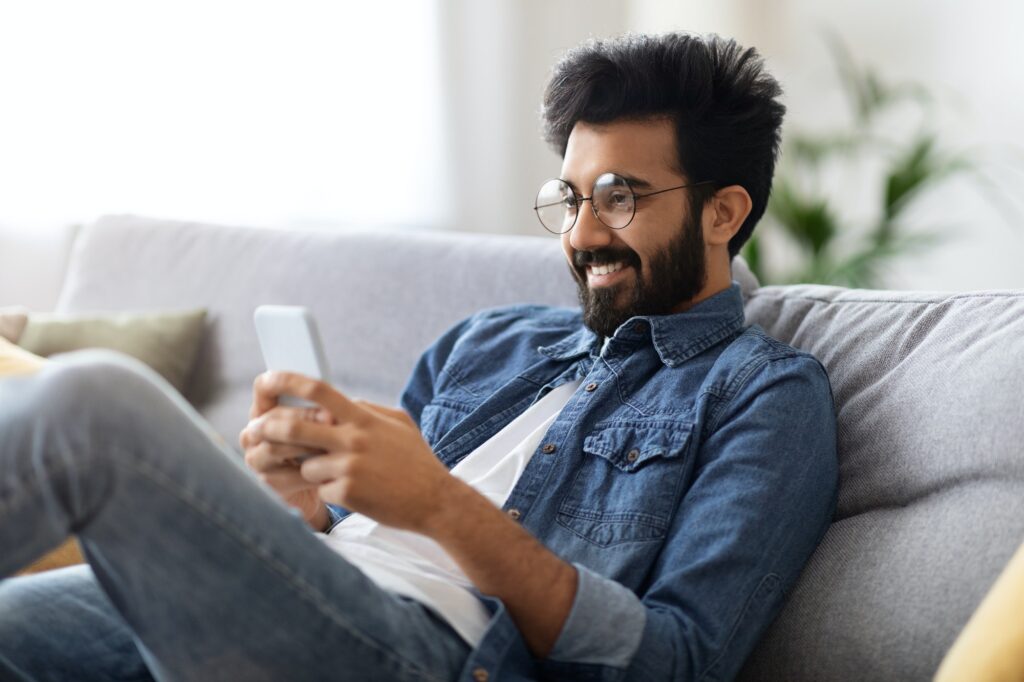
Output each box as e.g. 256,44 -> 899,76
440,0 -> 627,235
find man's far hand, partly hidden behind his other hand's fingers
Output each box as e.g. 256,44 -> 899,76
239,382 -> 334,530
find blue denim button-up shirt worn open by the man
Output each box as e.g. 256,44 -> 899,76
331,284 -> 838,681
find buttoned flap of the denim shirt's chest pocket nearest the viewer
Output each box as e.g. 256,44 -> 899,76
583,422 -> 693,471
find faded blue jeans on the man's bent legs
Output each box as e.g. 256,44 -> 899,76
0,351 -> 470,681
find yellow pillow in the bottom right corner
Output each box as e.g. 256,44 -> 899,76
935,545 -> 1024,682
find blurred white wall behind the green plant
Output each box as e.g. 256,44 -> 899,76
630,0 -> 1024,290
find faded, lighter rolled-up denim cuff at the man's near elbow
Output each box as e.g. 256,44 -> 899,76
548,563 -> 647,669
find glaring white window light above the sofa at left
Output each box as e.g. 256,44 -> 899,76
0,0 -> 447,227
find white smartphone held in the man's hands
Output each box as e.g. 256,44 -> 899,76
253,305 -> 331,408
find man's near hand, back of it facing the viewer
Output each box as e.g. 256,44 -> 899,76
244,372 -> 455,532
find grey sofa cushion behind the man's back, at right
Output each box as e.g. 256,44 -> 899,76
740,286 -> 1024,681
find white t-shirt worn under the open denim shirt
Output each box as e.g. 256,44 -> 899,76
321,380 -> 582,647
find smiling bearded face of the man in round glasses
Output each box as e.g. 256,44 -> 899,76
561,119 -> 707,336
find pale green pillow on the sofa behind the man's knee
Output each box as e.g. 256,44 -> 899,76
17,309 -> 206,392
